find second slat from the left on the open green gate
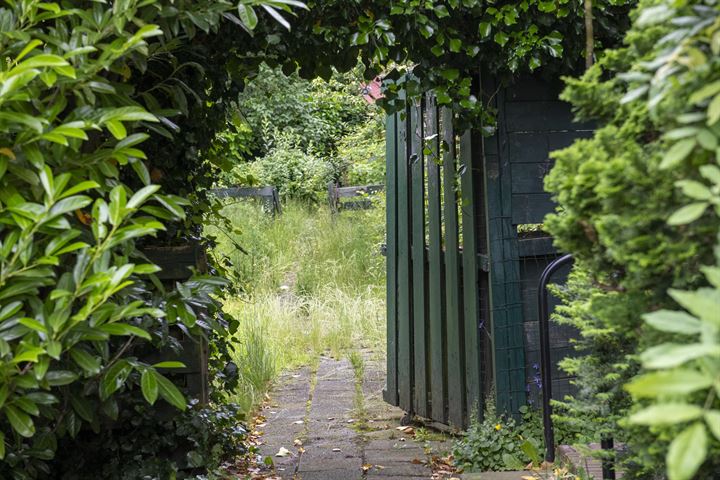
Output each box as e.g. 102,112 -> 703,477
397,98 -> 413,412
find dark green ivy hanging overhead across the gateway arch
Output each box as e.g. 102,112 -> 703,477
240,0 -> 633,120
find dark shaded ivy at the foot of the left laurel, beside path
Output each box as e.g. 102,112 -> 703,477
53,399 -> 247,480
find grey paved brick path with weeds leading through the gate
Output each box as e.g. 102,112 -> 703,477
255,352 -> 451,480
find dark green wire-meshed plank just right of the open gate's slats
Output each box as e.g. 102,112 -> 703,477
483,75 -> 526,414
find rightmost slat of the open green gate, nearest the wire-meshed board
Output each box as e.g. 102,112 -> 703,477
460,130 -> 482,417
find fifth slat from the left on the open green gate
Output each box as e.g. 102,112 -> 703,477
441,108 -> 465,427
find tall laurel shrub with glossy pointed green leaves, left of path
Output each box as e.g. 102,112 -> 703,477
0,0 -> 300,479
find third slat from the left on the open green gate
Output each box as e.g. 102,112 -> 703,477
408,100 -> 428,417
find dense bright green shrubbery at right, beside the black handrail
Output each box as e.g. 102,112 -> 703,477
546,2 -> 720,479
